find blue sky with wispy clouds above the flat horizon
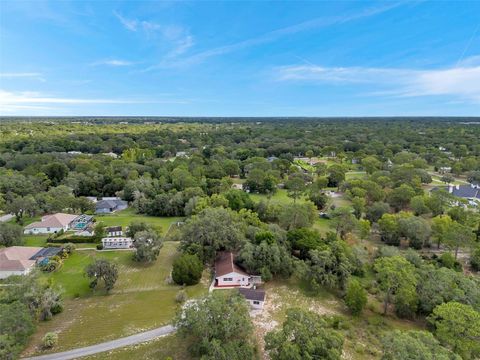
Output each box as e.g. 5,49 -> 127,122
0,1 -> 480,116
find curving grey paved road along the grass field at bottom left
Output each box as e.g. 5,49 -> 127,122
24,325 -> 175,360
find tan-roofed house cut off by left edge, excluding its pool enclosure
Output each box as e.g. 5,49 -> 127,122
0,246 -> 42,279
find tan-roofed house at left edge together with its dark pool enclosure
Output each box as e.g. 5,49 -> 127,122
0,246 -> 62,279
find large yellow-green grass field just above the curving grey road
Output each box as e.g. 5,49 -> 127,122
24,242 -> 209,355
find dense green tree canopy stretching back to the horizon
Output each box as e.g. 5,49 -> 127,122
0,117 -> 480,359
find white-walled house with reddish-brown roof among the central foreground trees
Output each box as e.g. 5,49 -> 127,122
215,252 -> 262,288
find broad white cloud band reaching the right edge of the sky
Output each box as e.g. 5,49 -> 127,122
274,57 -> 480,103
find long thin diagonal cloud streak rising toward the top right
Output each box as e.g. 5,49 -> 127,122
147,3 -> 402,70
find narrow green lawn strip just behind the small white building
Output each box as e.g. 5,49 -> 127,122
95,208 -> 183,234
